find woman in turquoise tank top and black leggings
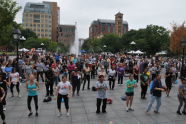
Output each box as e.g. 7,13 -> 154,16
26,74 -> 39,117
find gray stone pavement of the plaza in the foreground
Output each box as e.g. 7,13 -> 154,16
0,75 -> 186,124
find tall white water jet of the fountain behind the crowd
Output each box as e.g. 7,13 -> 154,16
70,23 -> 79,56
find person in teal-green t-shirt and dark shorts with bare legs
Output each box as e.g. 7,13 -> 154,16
125,74 -> 137,112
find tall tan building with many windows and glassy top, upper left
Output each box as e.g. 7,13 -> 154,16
22,2 -> 59,41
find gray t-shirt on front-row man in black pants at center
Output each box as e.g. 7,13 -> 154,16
96,81 -> 109,99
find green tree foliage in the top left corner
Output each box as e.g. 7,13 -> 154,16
0,0 -> 21,45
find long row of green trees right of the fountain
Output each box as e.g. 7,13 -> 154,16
82,25 -> 169,55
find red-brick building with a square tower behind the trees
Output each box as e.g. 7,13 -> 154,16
89,13 -> 128,38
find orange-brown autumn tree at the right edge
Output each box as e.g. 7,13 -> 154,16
170,22 -> 186,54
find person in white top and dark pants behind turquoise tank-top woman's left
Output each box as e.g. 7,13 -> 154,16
9,68 -> 21,97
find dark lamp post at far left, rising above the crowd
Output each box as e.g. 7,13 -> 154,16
13,29 -> 21,71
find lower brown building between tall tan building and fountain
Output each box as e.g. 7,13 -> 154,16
57,25 -> 76,46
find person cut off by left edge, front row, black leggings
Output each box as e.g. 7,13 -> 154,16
0,87 -> 6,124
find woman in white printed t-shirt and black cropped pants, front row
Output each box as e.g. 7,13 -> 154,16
57,76 -> 72,116
